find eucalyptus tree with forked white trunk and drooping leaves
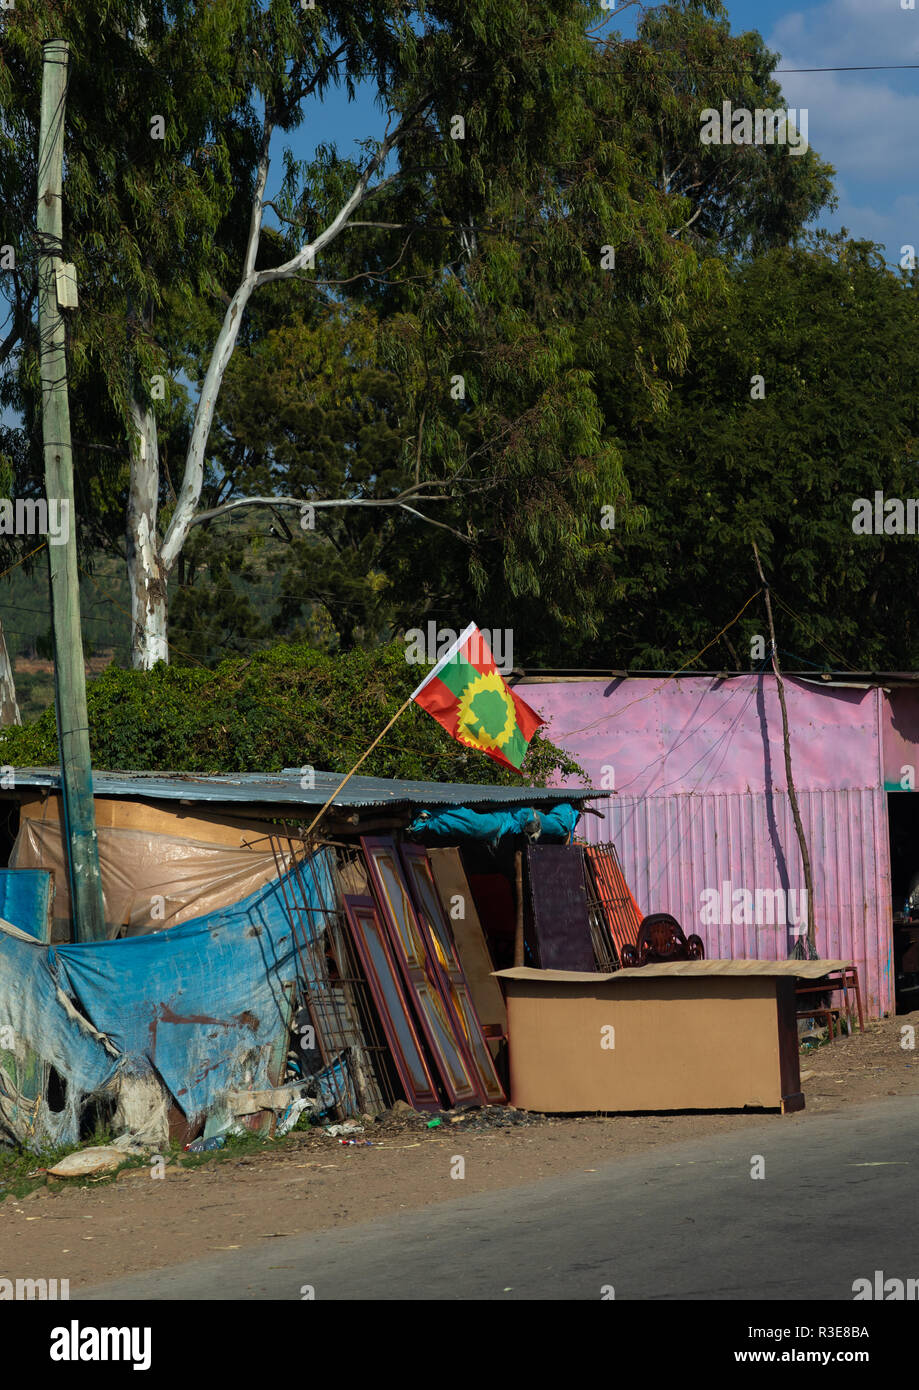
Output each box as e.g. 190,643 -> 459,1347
0,0 -> 622,666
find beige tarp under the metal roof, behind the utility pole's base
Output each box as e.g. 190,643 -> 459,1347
10,819 -> 286,937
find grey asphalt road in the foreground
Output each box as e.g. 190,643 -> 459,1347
80,1098 -> 919,1301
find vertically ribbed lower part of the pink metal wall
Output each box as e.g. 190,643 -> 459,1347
581,791 -> 893,1017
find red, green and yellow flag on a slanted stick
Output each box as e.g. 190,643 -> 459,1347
412,623 -> 546,771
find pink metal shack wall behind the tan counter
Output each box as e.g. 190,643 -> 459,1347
517,671 -> 919,1017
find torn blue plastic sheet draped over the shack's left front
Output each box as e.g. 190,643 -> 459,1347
0,851 -> 341,1148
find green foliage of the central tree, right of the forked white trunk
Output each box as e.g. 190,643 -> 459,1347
172,0 -> 831,664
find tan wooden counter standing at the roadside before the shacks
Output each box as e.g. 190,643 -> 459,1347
495,960 -> 849,1113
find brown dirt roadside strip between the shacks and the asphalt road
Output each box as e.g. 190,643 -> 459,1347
0,1012 -> 919,1297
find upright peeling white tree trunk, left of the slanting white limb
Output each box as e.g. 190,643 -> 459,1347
127,400 -> 170,671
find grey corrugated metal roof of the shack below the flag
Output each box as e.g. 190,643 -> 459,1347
8,767 -> 608,806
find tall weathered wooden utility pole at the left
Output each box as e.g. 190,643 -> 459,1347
38,39 -> 106,941
